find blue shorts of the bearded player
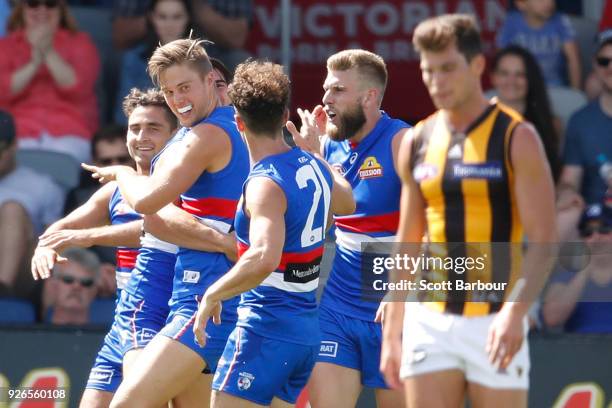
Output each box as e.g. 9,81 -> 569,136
317,307 -> 388,388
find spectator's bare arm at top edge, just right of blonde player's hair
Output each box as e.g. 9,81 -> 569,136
193,0 -> 249,48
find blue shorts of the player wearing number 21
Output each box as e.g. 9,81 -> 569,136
212,327 -> 319,405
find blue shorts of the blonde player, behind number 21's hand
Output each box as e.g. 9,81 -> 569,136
159,297 -> 236,374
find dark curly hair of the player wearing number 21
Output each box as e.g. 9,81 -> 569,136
227,60 -> 291,138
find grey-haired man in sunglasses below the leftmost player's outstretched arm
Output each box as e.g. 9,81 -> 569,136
43,248 -> 100,325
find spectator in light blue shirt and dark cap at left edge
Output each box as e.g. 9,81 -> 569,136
0,110 -> 64,297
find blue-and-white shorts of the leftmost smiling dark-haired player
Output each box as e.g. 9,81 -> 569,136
85,290 -> 168,393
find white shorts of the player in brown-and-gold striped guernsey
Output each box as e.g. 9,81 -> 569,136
400,302 -> 529,390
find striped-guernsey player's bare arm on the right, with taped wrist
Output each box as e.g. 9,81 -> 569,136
487,124 -> 557,368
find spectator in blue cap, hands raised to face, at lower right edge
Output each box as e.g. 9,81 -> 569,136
542,204 -> 612,333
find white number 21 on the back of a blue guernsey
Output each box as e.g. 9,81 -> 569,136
295,160 -> 331,248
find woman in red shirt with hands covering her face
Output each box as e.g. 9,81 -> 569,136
0,0 -> 100,162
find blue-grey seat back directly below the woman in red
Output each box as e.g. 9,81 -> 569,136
17,150 -> 81,191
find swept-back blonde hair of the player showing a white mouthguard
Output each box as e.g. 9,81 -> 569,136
147,38 -> 212,85
